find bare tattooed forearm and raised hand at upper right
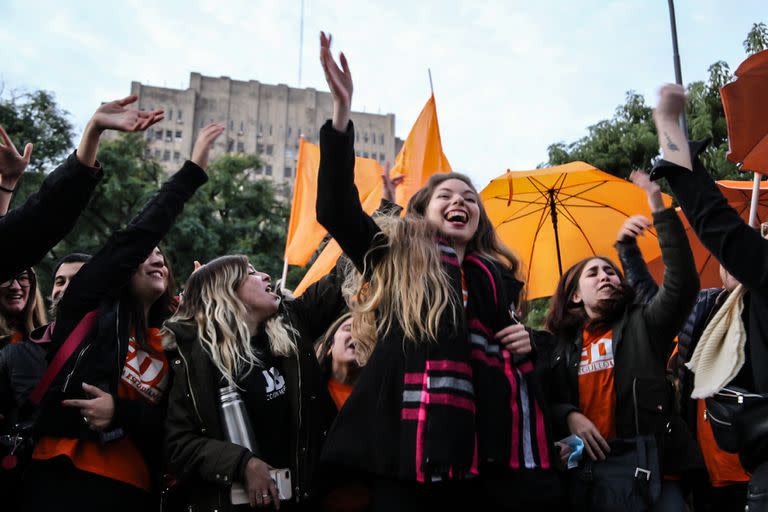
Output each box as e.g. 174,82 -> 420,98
653,84 -> 693,171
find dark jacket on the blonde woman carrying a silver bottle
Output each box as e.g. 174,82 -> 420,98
165,273 -> 346,511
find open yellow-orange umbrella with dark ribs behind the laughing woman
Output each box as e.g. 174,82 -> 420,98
480,162 -> 672,299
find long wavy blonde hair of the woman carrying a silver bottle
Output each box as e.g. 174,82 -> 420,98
165,255 -> 297,386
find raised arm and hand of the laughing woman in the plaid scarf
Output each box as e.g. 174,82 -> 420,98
316,32 -> 381,271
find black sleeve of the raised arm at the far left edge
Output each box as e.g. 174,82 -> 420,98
0,153 -> 102,283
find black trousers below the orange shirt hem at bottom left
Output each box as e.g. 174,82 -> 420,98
20,457 -> 153,512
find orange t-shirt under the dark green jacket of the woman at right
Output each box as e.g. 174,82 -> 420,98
579,329 -> 616,440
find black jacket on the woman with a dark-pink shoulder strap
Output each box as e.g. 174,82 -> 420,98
36,161 -> 208,482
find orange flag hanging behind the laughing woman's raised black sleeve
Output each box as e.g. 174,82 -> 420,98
285,138 -> 383,267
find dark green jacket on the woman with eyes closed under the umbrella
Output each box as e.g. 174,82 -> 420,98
549,208 -> 699,474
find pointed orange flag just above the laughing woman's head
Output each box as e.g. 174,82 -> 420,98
390,94 -> 451,208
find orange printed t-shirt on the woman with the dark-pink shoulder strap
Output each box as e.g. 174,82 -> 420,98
32,329 -> 169,491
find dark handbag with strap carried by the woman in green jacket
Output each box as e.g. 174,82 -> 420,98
569,379 -> 661,512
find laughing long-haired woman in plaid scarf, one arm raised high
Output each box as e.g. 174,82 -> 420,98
317,33 -> 559,510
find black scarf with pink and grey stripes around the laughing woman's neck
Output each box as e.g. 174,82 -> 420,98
401,240 -> 550,482
